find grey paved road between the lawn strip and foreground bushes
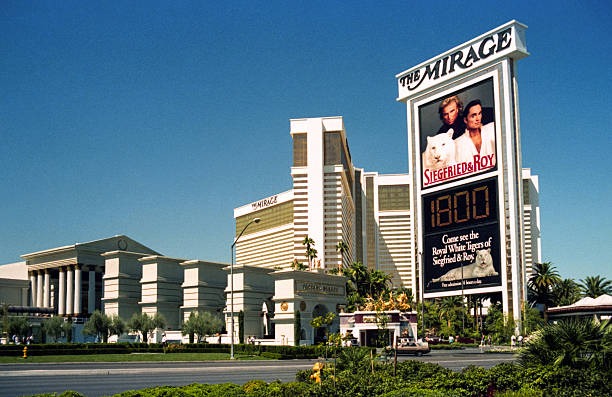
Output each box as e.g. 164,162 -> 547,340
0,349 -> 514,397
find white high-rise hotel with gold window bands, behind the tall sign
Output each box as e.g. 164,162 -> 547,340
234,117 -> 541,292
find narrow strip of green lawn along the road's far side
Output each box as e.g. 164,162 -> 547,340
0,353 -> 268,364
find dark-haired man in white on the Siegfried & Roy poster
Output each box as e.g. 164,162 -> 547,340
455,99 -> 496,166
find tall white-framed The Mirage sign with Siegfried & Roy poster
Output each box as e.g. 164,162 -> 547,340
396,21 -> 529,304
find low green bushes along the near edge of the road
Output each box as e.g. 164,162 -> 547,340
26,353 -> 612,397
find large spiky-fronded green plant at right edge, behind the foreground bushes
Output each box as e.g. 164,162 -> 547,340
519,319 -> 612,371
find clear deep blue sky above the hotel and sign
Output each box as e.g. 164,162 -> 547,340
0,0 -> 612,279
